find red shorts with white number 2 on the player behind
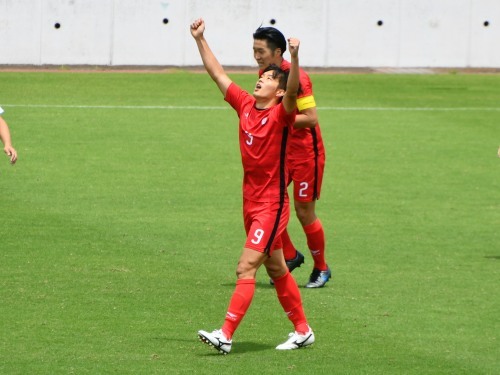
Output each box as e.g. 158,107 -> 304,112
287,154 -> 325,202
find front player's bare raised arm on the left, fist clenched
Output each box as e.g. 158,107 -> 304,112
191,18 -> 232,96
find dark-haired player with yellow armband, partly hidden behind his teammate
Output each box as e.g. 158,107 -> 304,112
253,27 -> 331,288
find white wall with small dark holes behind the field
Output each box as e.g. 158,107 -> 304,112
0,0 -> 500,68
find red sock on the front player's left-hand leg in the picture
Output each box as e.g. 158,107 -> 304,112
222,279 -> 255,340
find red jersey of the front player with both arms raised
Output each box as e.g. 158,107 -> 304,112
224,83 -> 295,202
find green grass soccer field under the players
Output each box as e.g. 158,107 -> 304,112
0,72 -> 500,375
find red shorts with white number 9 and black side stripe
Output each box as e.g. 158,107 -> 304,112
243,199 -> 290,255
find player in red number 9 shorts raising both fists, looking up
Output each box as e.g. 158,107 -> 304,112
191,19 -> 314,354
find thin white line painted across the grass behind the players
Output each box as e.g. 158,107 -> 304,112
0,104 -> 500,112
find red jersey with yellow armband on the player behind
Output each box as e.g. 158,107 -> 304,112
259,59 -> 325,160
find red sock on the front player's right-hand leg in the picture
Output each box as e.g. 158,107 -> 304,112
273,272 -> 309,334
